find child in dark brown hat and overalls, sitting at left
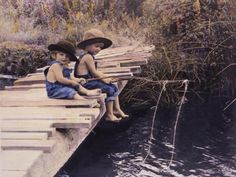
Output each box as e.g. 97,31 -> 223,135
44,40 -> 100,99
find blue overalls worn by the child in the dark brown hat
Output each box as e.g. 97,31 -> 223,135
44,60 -> 77,99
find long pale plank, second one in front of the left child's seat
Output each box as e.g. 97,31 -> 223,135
0,107 -> 100,120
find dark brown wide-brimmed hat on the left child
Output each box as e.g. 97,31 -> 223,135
48,40 -> 77,61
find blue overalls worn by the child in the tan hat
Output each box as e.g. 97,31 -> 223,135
74,53 -> 119,102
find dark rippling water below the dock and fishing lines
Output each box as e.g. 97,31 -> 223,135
57,97 -> 236,177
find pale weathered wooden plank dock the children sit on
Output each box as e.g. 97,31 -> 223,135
0,46 -> 152,177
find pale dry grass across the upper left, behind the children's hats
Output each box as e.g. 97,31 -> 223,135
0,0 -> 146,45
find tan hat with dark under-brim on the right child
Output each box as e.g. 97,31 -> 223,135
77,29 -> 112,49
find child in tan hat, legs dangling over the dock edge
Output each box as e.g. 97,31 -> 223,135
74,29 -> 128,122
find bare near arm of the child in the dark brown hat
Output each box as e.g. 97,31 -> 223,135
50,63 -> 78,86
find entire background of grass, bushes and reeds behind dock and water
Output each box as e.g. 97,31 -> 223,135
0,0 -> 236,104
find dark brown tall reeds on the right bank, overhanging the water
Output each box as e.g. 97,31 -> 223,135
124,0 -> 236,104
